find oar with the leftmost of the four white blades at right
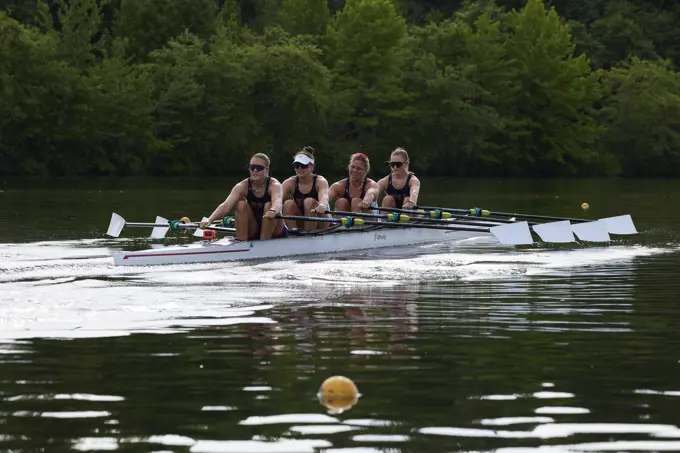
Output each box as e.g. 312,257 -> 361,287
276,215 -> 534,245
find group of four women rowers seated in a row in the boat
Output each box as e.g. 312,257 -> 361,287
200,146 -> 420,240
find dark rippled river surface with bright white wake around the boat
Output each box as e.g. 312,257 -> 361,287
0,179 -> 680,453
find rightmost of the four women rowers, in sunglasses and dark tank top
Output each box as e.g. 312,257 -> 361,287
378,148 -> 420,209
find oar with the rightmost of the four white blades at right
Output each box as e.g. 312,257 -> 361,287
418,206 -> 638,235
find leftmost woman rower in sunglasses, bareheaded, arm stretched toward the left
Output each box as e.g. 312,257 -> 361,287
199,153 -> 288,241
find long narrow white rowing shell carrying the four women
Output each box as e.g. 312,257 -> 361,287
113,222 -> 491,266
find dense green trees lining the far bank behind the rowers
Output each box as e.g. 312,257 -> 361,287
0,0 -> 680,176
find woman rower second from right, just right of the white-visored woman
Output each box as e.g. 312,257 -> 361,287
329,153 -> 380,212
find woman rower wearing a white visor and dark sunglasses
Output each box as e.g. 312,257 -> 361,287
282,146 -> 328,230
